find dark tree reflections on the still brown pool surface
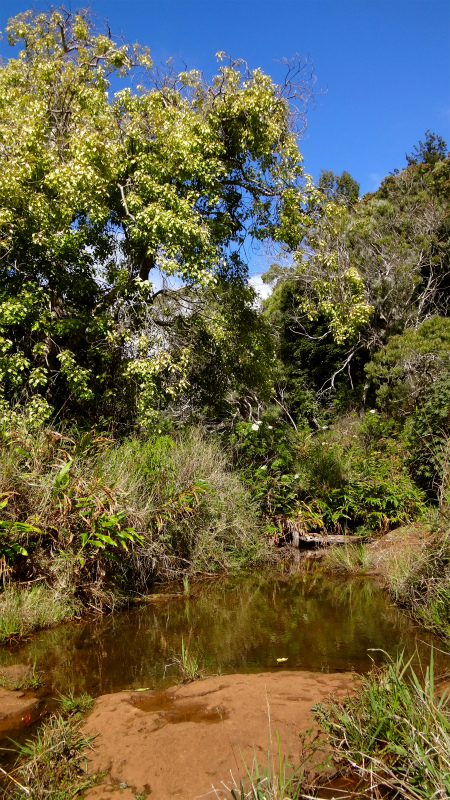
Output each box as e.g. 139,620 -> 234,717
0,570 -> 440,694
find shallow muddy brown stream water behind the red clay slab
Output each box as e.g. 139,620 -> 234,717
0,569 -> 450,796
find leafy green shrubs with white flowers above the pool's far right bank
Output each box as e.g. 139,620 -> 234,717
234,412 -> 425,532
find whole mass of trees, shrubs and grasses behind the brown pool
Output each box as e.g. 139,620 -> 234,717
0,7 -> 450,639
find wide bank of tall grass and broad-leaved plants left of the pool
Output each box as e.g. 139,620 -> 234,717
0,422 -> 264,616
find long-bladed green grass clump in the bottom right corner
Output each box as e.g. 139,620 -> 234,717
314,656 -> 450,800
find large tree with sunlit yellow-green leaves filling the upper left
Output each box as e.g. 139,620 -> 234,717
0,7 -> 311,428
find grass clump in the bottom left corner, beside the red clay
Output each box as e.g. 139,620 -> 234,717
4,695 -> 97,800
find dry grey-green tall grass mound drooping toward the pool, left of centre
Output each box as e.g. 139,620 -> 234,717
104,429 -> 268,582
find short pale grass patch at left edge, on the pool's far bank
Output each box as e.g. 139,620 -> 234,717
0,584 -> 79,642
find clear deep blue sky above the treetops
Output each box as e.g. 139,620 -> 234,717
0,0 -> 450,192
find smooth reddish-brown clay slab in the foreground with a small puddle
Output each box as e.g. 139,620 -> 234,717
84,672 -> 355,800
